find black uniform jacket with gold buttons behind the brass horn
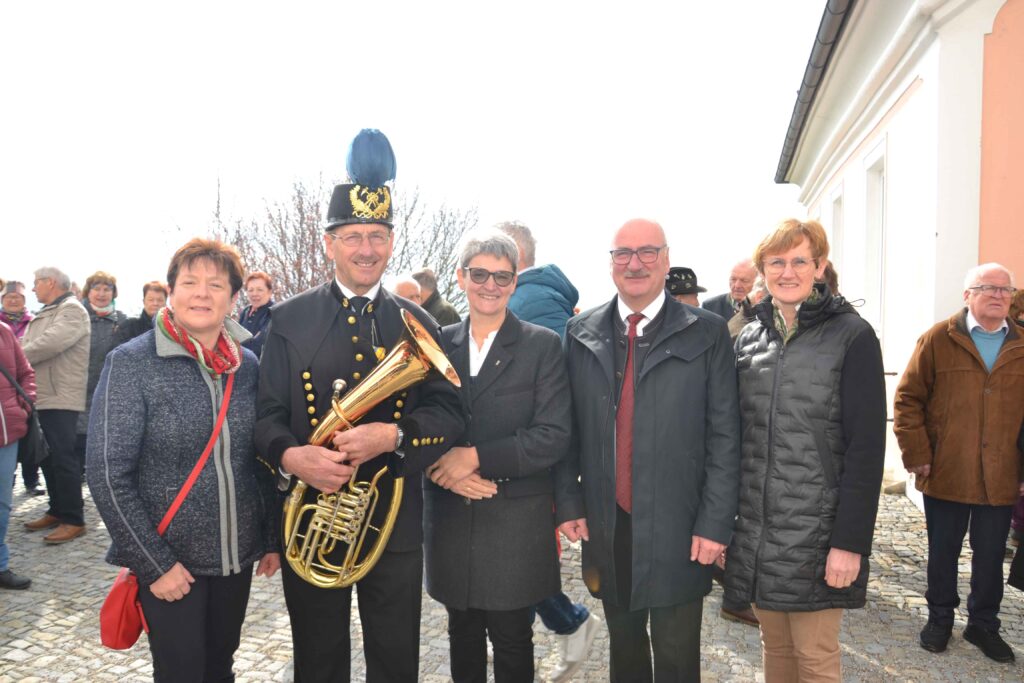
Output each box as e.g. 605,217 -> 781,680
254,282 -> 464,551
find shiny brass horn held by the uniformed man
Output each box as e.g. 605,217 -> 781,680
284,309 -> 461,588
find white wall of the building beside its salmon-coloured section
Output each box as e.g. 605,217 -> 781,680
790,0 -> 1005,505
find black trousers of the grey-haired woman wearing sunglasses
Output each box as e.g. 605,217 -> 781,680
447,605 -> 534,683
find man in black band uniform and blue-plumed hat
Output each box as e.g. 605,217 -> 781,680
256,130 -> 464,683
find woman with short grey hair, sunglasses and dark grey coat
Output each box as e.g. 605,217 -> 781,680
424,232 -> 571,683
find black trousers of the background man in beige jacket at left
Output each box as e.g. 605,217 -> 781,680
39,411 -> 85,526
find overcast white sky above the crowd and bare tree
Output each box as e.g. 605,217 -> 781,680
0,0 -> 824,313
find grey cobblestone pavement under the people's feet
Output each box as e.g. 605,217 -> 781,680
0,489 -> 1024,683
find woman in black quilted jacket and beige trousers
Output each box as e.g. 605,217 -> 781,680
725,219 -> 886,683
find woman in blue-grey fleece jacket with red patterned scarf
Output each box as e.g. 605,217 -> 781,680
87,239 -> 281,682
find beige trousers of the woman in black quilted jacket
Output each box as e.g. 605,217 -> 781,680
754,607 -> 843,683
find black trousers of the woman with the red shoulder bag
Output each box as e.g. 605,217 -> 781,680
138,566 -> 253,683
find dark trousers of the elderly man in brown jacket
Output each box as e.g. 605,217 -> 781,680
925,496 -> 1014,631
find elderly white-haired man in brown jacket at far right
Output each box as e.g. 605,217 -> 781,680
894,263 -> 1024,661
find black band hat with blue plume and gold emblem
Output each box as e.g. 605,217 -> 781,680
324,128 -> 396,231
